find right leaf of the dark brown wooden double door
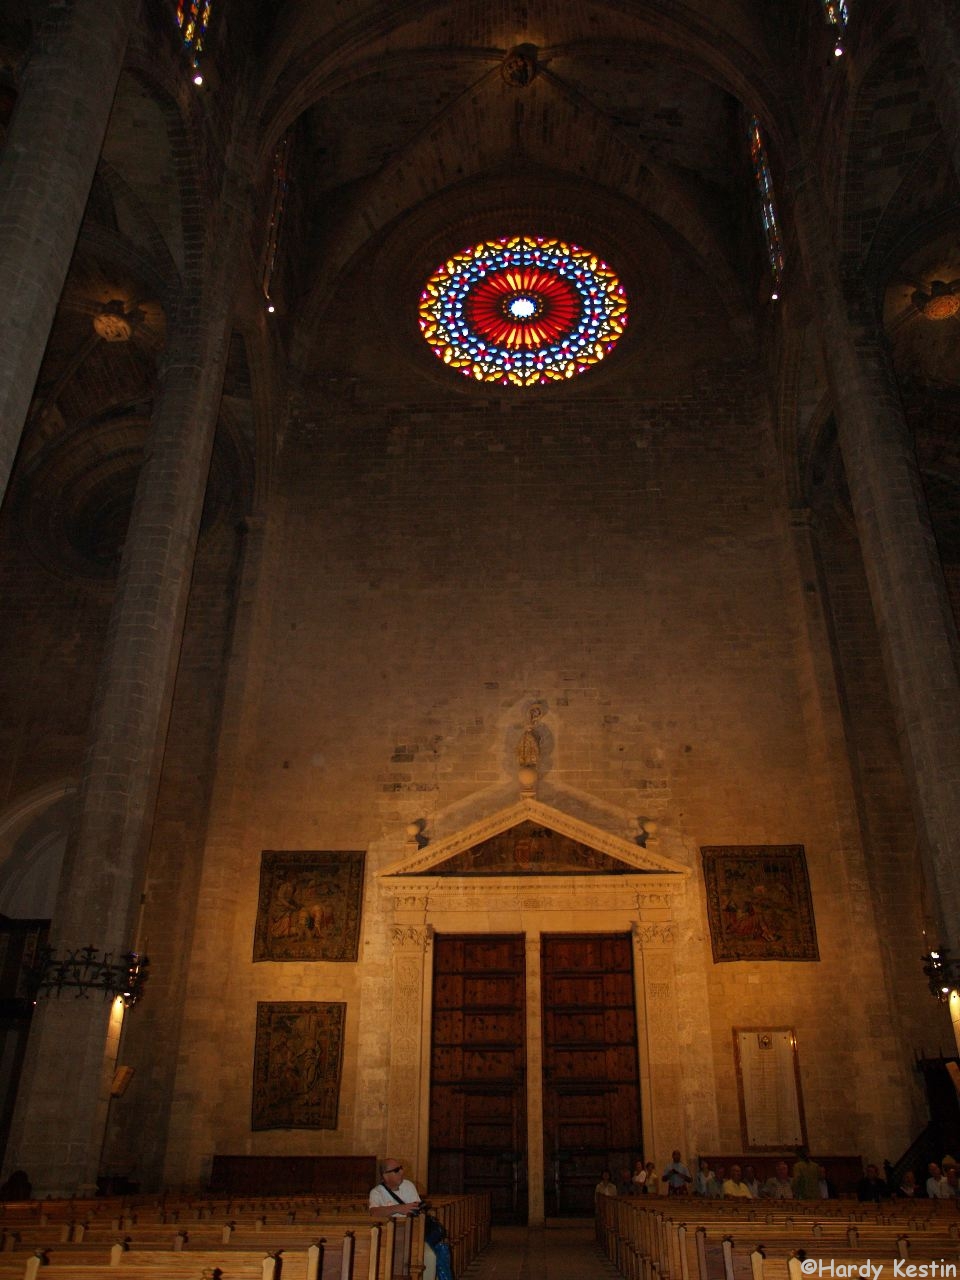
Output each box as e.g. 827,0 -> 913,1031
541,934 -> 643,1216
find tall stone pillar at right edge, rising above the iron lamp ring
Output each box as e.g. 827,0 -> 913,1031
792,165 -> 960,950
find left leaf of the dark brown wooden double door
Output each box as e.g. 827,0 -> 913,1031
429,934 -> 527,1222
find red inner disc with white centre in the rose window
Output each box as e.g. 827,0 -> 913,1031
463,266 -> 582,351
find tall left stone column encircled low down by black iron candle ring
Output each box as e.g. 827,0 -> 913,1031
6,186 -> 244,1196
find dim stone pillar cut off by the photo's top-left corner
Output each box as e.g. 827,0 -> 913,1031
0,0 -> 140,499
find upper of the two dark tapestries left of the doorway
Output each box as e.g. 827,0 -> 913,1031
253,850 -> 364,961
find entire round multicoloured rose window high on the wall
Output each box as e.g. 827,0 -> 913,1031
420,236 -> 627,387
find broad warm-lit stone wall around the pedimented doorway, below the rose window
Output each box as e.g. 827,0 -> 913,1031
154,335 -> 913,1181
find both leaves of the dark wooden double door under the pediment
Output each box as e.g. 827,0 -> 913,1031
429,933 -> 643,1222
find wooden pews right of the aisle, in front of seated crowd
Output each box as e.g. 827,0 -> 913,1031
596,1196 -> 960,1280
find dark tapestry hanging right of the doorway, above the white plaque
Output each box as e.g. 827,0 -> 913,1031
700,845 -> 820,963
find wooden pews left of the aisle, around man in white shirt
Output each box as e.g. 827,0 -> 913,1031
0,1196 -> 490,1280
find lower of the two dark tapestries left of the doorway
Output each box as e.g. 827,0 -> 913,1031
251,1001 -> 347,1129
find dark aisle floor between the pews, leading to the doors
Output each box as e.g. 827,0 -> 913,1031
457,1219 -> 617,1280
